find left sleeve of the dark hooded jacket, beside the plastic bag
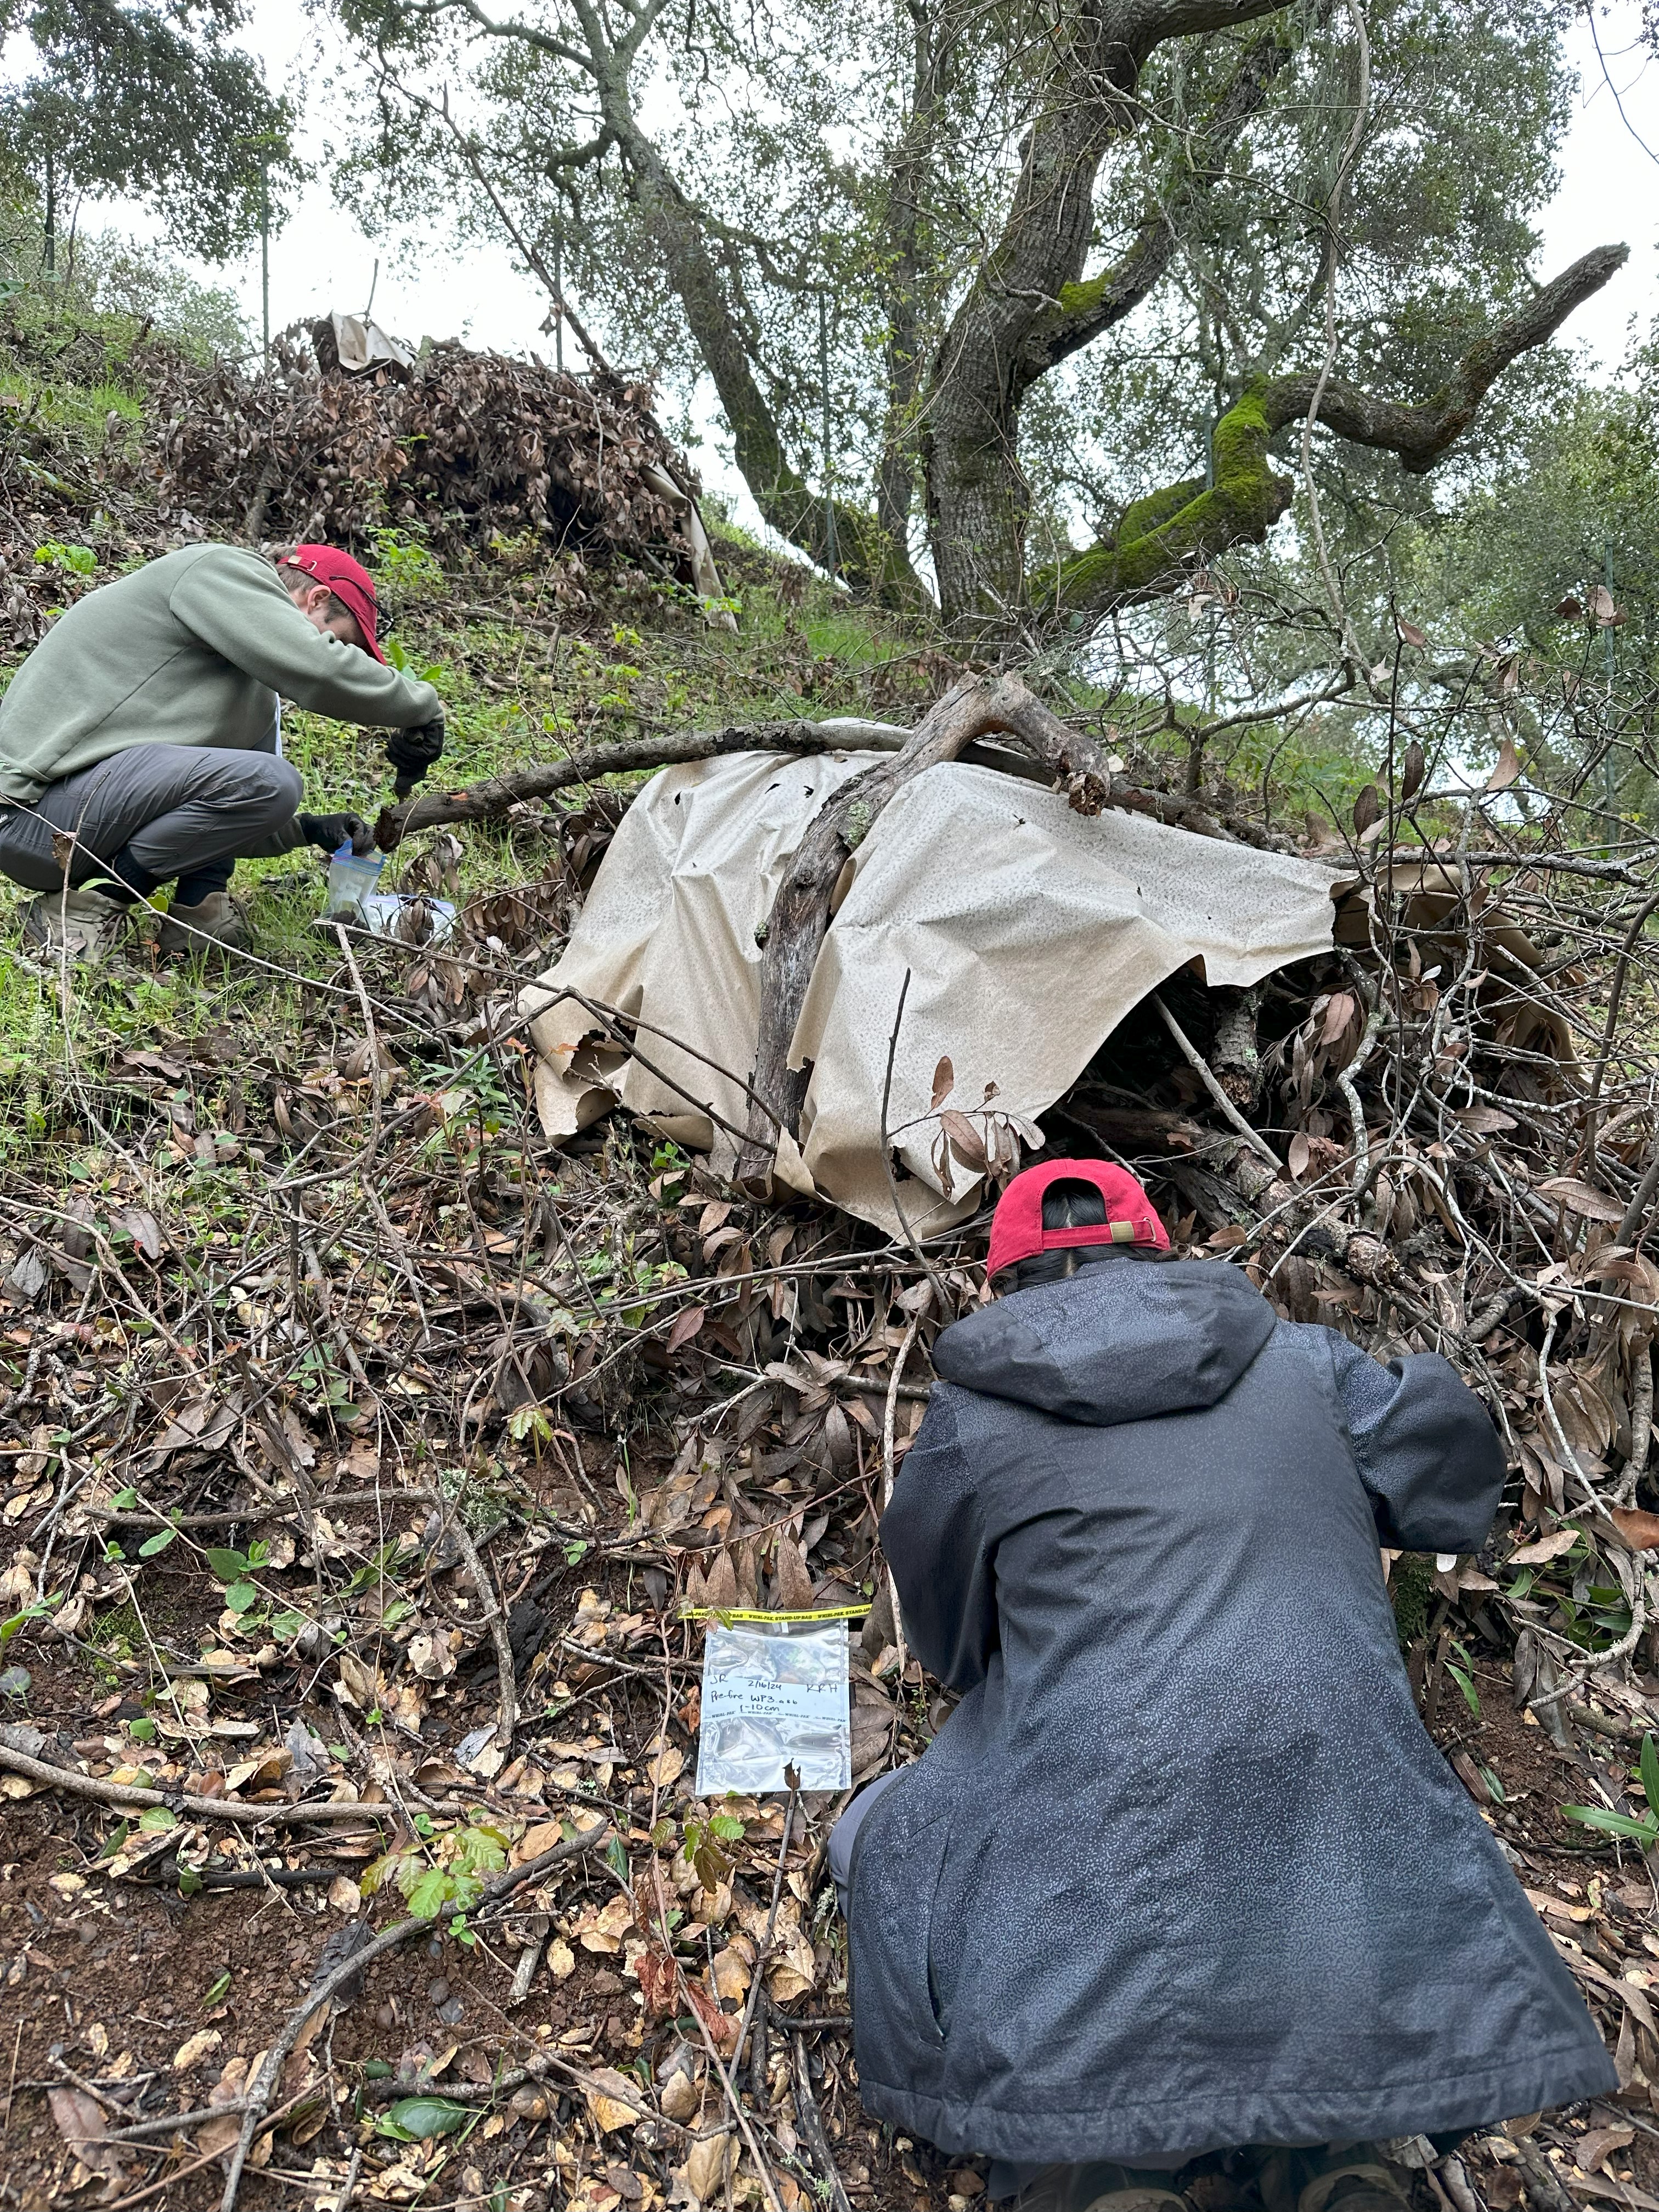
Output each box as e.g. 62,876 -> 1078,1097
881,1383 -> 997,1690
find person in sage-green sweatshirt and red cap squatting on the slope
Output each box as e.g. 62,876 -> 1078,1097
0,544 -> 444,958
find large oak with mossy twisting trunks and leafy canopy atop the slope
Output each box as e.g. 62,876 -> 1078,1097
334,0 -> 1623,628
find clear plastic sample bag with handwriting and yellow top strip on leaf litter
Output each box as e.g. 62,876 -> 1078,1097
697,1615 -> 851,1796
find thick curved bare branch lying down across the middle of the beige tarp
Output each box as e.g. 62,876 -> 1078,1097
737,677 -> 1113,1194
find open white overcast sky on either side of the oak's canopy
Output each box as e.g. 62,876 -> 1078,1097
97,0 -> 1659,511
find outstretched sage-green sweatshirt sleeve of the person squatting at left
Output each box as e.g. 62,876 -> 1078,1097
168,546 -> 442,730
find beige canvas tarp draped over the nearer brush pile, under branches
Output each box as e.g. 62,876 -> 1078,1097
524,752 -> 1352,1234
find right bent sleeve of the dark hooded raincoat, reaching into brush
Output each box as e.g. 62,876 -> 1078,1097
1281,1323 -> 1504,1550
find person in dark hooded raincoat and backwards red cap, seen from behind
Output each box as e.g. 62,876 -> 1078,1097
830,1159 -> 1617,2212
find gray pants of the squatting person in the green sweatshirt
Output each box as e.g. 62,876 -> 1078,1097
0,746 -> 301,898
